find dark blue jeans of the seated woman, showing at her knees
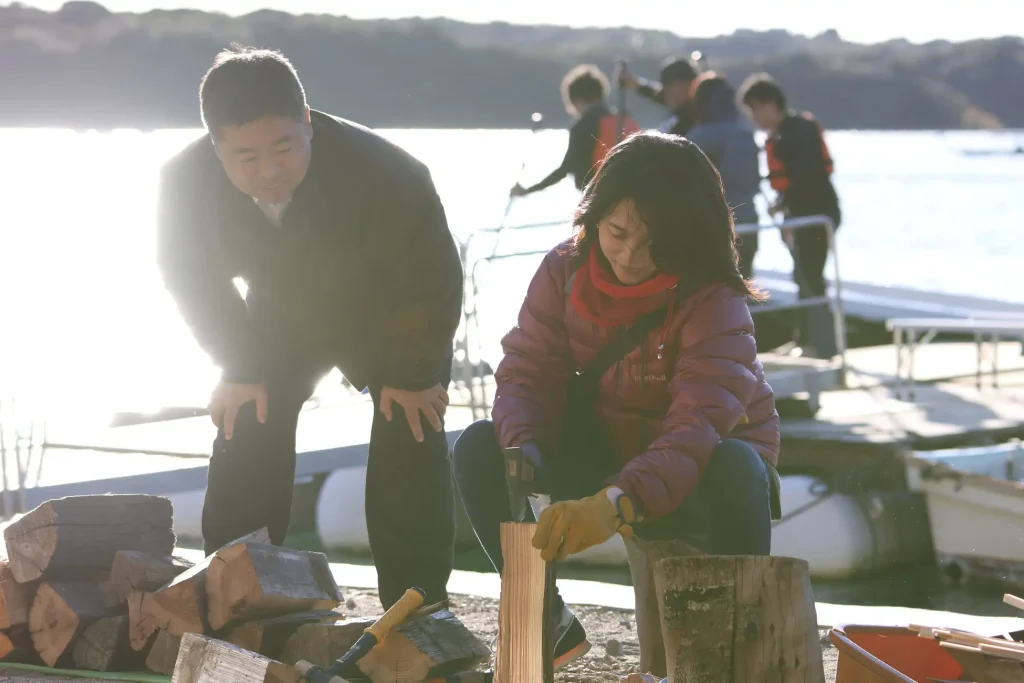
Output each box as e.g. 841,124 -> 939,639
454,420 -> 771,573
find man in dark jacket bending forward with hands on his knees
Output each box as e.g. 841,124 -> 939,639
158,47 -> 463,607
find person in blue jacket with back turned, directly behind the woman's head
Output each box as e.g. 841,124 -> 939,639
686,72 -> 761,278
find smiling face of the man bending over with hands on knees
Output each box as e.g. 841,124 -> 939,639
214,110 -> 313,204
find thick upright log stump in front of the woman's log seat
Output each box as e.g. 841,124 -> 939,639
654,555 -> 825,683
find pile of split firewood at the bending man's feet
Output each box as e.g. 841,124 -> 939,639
0,495 -> 489,683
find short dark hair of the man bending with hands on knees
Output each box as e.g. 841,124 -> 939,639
199,44 -> 306,136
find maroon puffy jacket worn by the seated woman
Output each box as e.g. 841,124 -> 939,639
493,245 -> 779,519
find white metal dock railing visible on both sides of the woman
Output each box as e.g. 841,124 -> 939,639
456,215 -> 847,420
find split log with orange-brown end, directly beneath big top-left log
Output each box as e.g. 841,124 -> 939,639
29,581 -> 110,667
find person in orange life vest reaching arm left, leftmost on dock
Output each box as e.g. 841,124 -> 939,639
510,65 -> 640,197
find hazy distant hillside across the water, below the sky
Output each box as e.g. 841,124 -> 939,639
0,2 -> 1024,129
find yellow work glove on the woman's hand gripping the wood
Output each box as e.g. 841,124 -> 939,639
534,486 -> 640,562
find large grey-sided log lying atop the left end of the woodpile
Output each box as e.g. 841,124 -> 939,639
4,495 -> 174,583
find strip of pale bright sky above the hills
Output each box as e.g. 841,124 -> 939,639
23,0 -> 1024,42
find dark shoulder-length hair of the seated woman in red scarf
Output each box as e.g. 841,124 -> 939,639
572,132 -> 768,302
